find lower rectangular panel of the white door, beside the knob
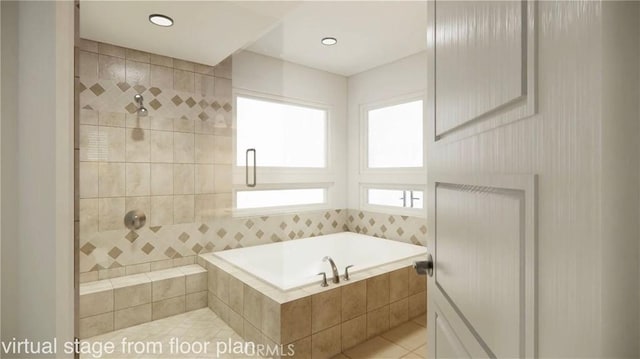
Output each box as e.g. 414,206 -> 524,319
429,175 -> 537,358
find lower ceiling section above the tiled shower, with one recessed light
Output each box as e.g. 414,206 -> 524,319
80,0 -> 298,65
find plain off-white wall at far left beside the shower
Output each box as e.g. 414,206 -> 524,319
1,1 -> 74,354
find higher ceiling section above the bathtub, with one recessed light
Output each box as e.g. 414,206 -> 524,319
247,1 -> 427,76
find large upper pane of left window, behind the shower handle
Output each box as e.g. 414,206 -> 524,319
236,97 -> 327,168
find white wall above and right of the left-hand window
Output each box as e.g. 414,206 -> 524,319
233,51 -> 347,208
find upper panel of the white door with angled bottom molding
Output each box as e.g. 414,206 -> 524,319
428,0 -> 537,143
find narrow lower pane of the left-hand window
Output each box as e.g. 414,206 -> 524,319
236,188 -> 325,209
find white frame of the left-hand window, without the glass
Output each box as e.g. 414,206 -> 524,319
231,88 -> 337,218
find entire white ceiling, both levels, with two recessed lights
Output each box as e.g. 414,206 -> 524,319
80,0 -> 426,76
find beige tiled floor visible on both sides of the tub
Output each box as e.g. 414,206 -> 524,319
80,308 -> 427,359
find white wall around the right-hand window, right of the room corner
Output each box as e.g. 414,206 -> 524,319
347,52 -> 427,209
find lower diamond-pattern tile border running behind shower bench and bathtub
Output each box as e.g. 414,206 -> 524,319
80,209 -> 426,282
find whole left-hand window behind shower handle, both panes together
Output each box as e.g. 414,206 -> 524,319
234,92 -> 335,215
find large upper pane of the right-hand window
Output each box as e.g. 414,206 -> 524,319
367,100 -> 424,168
